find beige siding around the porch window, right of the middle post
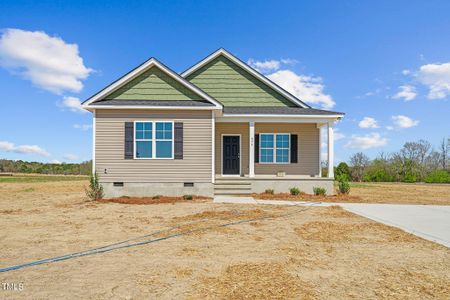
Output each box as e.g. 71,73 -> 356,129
255,123 -> 320,175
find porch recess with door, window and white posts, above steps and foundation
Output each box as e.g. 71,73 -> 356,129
214,120 -> 334,178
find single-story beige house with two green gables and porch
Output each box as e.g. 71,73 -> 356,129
83,49 -> 344,197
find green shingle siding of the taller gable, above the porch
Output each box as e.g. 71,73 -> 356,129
186,56 -> 296,106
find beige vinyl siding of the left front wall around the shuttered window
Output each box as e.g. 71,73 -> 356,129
95,110 -> 212,182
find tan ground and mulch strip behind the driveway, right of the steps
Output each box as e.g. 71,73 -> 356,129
253,182 -> 450,205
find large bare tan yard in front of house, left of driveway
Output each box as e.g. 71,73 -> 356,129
0,180 -> 450,299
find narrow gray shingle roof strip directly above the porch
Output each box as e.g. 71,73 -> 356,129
223,106 -> 344,115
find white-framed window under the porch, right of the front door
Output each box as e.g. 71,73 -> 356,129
259,133 -> 290,164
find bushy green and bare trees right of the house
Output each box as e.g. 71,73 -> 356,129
326,138 -> 450,183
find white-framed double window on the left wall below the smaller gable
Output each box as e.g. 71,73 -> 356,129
135,122 -> 173,159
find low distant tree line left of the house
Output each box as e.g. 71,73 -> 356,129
0,159 -> 92,175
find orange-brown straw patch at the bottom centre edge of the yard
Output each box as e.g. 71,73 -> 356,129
190,263 -> 316,299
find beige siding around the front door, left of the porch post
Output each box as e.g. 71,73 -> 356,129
215,123 -> 249,175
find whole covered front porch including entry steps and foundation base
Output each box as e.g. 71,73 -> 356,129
213,116 -> 335,194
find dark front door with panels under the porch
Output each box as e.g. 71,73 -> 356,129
222,135 -> 241,175
